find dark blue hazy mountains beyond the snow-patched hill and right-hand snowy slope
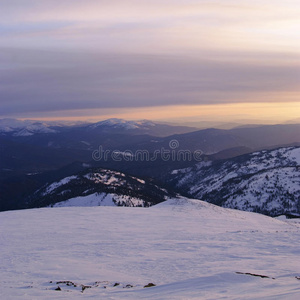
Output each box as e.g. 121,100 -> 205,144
0,119 -> 300,210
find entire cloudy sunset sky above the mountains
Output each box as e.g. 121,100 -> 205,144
0,0 -> 300,122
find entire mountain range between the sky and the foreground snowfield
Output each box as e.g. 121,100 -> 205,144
0,119 -> 300,215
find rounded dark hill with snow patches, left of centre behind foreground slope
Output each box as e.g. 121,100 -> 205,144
27,168 -> 176,207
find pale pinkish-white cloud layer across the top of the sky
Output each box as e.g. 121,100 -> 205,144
0,0 -> 300,53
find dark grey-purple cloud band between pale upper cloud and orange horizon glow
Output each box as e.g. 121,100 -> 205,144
0,49 -> 299,114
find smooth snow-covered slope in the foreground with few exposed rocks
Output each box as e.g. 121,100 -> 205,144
0,198 -> 300,300
